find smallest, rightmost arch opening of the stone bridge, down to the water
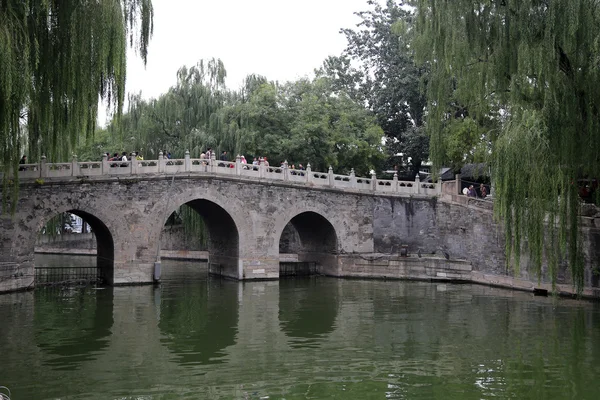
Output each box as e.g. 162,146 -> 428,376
279,211 -> 338,277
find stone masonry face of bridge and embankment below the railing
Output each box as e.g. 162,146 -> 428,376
0,174 -> 600,297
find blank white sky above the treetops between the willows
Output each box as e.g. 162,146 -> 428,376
99,0 -> 378,125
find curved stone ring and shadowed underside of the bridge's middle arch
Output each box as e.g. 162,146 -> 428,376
150,187 -> 252,279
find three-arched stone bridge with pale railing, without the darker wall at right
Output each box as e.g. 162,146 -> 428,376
0,155 -> 446,289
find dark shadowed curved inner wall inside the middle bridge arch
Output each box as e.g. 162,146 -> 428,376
168,199 -> 241,279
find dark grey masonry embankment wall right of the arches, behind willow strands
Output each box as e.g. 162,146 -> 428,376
373,196 -> 600,296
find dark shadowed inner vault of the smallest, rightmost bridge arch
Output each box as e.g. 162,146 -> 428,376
279,211 -> 338,275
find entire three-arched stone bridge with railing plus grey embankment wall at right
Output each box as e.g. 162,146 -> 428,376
0,154 -> 592,292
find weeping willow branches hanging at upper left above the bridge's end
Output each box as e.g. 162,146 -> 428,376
0,0 -> 153,209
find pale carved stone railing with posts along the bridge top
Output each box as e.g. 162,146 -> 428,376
5,151 -> 442,196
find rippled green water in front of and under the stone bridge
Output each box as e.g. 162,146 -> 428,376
0,262 -> 600,400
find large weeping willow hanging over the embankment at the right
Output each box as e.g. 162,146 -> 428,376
411,0 -> 600,289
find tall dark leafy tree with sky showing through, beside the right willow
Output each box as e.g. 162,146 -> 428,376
318,0 -> 429,177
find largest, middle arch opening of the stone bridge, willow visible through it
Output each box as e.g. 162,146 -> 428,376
160,199 -> 240,279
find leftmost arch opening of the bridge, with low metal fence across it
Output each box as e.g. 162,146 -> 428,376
35,209 -> 115,285
